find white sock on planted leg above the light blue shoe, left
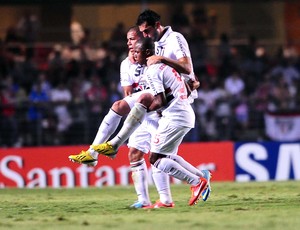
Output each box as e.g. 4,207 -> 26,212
130,159 -> 151,205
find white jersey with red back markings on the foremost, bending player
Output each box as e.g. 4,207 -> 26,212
146,64 -> 195,128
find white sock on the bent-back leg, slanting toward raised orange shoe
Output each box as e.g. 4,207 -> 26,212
154,157 -> 199,185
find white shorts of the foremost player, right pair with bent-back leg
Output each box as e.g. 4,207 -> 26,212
151,117 -> 191,155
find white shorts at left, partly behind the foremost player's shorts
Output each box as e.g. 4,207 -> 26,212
127,112 -> 159,153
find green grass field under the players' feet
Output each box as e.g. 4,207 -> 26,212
0,181 -> 300,230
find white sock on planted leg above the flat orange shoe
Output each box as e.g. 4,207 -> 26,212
151,165 -> 173,204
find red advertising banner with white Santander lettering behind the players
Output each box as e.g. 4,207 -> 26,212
0,142 -> 234,188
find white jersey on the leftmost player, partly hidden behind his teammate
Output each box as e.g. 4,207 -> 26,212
120,57 -> 148,92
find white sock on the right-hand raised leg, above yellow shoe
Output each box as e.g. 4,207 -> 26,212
110,103 -> 147,149
